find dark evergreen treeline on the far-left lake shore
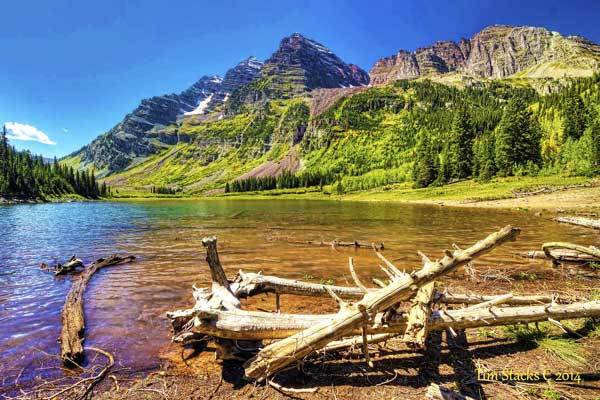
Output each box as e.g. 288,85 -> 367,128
0,127 -> 110,199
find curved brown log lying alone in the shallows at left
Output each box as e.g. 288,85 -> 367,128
59,255 -> 135,365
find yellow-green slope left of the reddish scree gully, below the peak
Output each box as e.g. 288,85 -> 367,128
108,100 -> 308,193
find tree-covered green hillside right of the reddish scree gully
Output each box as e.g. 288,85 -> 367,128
227,75 -> 600,192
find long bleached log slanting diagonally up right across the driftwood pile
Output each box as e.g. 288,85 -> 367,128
245,226 -> 519,380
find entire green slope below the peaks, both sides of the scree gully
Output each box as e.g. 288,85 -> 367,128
109,75 -> 600,193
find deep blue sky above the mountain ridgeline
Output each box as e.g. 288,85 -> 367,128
0,0 -> 600,156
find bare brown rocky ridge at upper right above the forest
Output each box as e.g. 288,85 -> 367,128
370,25 -> 600,85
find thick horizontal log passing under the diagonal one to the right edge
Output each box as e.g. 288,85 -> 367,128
169,296 -> 600,340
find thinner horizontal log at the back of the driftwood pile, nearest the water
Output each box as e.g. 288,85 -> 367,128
230,270 -> 552,305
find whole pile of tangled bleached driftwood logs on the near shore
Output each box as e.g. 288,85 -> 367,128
167,226 -> 600,390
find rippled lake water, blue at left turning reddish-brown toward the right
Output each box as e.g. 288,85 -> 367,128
0,200 -> 591,384
